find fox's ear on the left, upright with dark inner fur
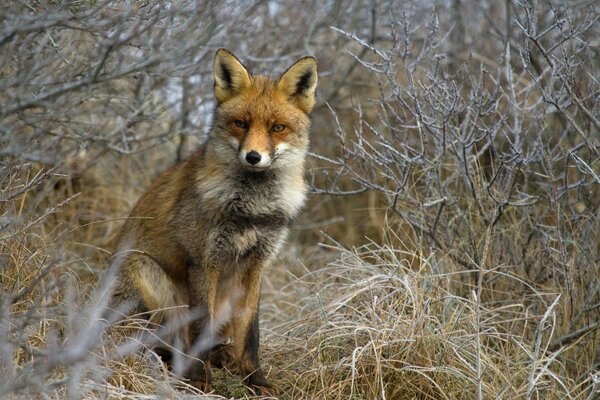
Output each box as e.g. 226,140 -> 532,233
213,48 -> 250,104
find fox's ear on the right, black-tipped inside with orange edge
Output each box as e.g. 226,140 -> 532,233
277,57 -> 317,114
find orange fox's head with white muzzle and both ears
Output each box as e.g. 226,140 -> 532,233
211,49 -> 317,171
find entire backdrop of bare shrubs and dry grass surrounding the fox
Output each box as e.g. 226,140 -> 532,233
0,0 -> 600,399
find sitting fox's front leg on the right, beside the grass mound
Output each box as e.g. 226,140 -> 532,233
232,266 -> 276,394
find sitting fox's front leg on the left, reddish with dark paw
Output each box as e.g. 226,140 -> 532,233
185,266 -> 220,392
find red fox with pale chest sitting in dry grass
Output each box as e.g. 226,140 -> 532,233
110,48 -> 318,394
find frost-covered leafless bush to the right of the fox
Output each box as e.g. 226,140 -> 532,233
313,2 -> 600,398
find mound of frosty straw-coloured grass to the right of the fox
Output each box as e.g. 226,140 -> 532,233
263,228 -> 572,399
